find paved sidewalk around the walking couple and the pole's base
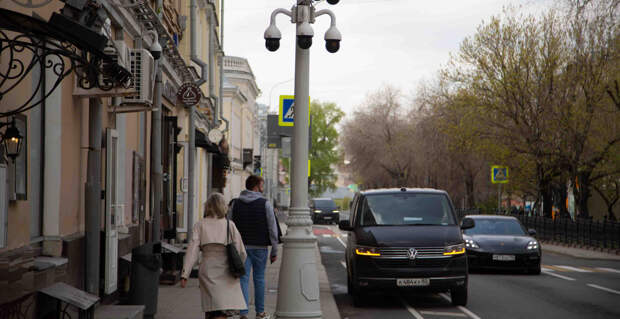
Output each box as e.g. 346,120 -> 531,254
155,223 -> 340,319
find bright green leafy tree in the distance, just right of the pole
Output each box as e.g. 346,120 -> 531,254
308,101 -> 344,197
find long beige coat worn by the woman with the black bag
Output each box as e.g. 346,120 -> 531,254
181,218 -> 247,312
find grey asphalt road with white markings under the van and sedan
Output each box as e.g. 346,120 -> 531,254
313,225 -> 620,319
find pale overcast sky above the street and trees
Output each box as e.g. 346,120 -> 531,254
224,0 -> 547,113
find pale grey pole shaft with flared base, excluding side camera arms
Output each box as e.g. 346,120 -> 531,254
275,5 -> 321,319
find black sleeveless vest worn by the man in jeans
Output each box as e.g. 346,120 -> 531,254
233,198 -> 271,246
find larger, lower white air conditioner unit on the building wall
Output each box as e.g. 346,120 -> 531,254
121,49 -> 155,106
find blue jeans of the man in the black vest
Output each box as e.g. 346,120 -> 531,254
240,248 -> 268,315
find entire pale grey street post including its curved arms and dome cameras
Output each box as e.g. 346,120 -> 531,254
265,0 -> 342,319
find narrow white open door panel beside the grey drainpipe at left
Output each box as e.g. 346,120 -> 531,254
104,129 -> 120,294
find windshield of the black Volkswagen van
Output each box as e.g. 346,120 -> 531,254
360,193 -> 456,226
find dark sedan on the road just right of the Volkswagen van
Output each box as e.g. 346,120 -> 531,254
463,215 -> 542,274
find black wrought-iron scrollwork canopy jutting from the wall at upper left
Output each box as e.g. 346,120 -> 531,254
0,9 -> 131,118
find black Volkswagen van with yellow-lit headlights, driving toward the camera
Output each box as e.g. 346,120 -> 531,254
340,188 -> 473,306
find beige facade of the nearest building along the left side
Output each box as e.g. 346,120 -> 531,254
0,0 -> 230,317
